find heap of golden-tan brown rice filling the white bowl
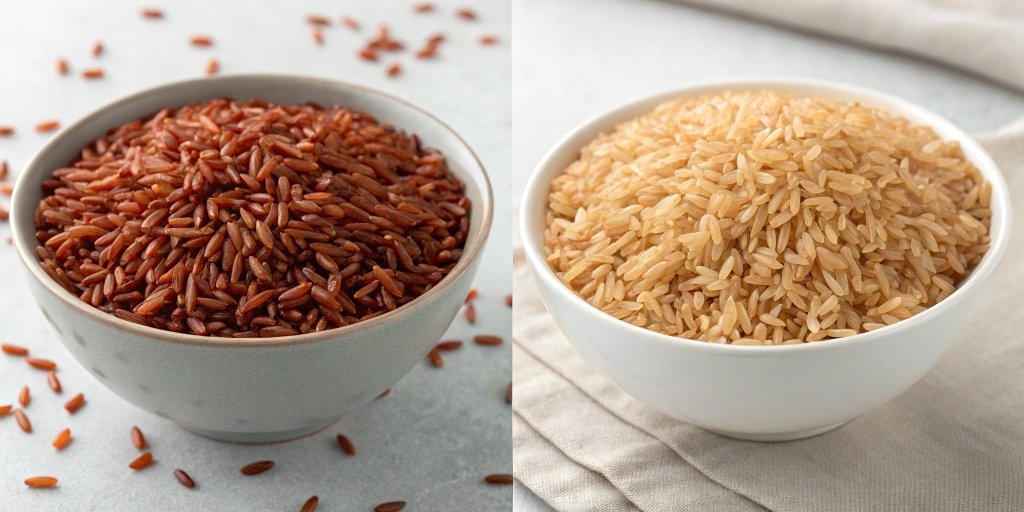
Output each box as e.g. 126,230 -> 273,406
545,92 -> 991,345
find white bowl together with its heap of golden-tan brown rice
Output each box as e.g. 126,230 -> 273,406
519,79 -> 1011,440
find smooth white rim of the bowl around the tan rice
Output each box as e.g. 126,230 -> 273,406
517,76 -> 1013,357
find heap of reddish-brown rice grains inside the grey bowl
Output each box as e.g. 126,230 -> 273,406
35,99 -> 470,337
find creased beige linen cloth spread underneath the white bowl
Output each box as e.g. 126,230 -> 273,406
513,120 -> 1024,512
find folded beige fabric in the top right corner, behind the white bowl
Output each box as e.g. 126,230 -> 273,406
674,0 -> 1024,90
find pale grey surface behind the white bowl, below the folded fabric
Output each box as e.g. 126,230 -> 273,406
512,0 -> 1024,512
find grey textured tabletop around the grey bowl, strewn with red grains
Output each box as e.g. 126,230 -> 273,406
0,0 -> 516,511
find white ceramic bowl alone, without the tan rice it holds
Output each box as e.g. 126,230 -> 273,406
519,79 -> 1011,440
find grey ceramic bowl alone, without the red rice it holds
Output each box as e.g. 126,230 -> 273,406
11,75 -> 493,442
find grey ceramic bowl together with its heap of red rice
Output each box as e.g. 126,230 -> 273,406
11,75 -> 493,442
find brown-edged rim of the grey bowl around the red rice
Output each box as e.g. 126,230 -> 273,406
10,73 -> 495,347
